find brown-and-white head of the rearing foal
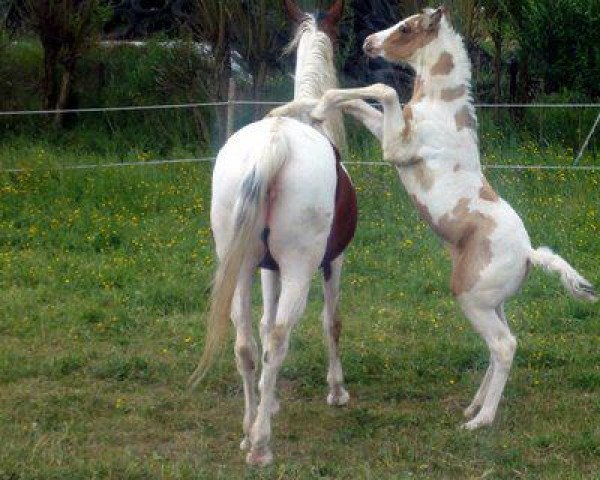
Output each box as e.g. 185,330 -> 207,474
363,6 -> 447,63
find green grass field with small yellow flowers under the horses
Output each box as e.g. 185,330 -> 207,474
0,137 -> 600,480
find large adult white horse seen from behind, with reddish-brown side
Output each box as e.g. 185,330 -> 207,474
191,0 -> 356,465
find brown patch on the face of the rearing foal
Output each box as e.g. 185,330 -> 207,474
383,15 -> 439,60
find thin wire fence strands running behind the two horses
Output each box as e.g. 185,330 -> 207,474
0,100 -> 600,173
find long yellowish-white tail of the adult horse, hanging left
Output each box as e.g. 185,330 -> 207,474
189,119 -> 289,388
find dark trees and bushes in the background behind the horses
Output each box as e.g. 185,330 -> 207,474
0,0 -> 600,155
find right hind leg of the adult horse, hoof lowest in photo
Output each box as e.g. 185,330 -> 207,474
246,265 -> 316,465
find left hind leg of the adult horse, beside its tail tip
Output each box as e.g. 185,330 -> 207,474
231,262 -> 258,450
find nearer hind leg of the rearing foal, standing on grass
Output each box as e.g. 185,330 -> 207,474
460,294 -> 517,430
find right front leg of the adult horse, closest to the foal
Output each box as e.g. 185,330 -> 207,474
323,255 -> 350,406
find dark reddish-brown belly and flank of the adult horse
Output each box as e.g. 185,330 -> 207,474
259,147 -> 358,280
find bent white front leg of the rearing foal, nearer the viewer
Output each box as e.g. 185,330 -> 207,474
311,83 -> 405,163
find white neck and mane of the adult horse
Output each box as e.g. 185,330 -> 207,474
284,15 -> 346,149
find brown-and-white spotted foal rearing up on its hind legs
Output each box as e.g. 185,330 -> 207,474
271,7 -> 597,429
